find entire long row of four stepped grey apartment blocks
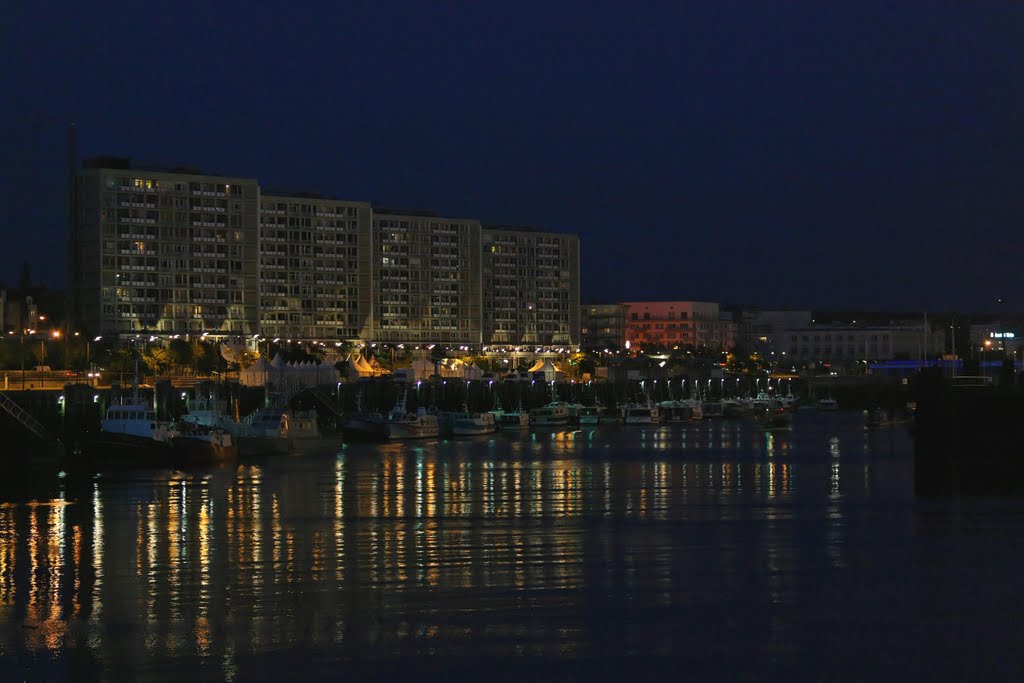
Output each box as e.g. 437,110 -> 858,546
69,157 -> 580,347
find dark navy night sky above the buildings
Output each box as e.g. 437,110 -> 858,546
0,0 -> 1024,311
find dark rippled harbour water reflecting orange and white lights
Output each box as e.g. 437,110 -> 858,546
0,413 -> 1024,681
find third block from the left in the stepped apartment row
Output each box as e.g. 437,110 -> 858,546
369,209 -> 483,346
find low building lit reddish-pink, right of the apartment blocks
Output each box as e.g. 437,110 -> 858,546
623,301 -> 734,350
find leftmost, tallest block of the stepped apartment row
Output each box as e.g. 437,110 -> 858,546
69,158 -> 259,336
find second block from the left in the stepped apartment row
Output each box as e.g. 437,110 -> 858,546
259,195 -> 374,341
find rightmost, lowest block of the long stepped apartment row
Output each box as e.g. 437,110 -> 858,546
482,226 -> 581,347
